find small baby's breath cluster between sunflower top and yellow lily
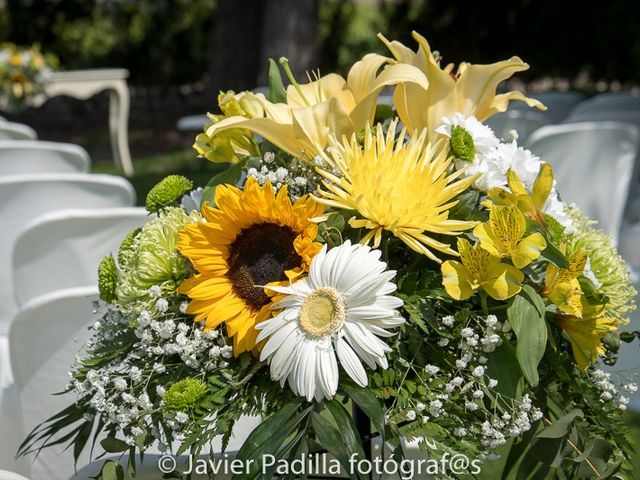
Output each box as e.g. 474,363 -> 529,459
247,152 -> 319,200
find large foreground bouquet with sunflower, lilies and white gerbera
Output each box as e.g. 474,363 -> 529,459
21,34 -> 636,479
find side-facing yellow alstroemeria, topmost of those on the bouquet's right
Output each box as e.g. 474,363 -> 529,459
488,163 -> 553,226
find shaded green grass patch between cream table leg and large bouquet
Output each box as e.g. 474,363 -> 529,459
91,149 -> 225,205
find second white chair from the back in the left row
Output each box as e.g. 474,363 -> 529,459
0,140 -> 91,176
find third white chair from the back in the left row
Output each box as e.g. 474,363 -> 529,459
0,173 -> 135,336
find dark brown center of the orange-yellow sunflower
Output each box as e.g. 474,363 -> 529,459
227,223 -> 302,310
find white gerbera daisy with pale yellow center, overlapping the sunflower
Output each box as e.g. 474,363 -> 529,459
256,241 -> 404,401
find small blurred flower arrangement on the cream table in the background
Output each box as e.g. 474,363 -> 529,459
0,43 -> 58,112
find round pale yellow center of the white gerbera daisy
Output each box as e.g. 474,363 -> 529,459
299,287 -> 345,337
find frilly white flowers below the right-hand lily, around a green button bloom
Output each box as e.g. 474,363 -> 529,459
436,113 -> 573,233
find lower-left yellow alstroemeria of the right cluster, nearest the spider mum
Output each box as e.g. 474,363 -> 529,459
441,238 -> 524,300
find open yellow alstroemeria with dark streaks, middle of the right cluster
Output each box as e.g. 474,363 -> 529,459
473,204 -> 547,268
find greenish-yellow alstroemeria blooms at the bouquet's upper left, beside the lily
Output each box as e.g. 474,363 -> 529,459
193,90 -> 264,163
